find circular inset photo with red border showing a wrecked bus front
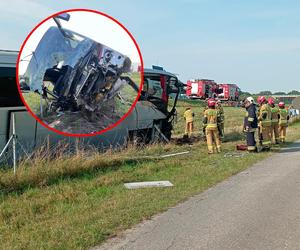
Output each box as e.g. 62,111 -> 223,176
17,9 -> 143,136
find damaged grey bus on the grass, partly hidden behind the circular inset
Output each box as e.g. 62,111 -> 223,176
0,50 -> 183,162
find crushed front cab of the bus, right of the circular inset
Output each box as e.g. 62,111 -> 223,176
127,66 -> 183,142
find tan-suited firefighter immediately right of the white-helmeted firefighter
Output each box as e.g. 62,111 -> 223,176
257,96 -> 271,150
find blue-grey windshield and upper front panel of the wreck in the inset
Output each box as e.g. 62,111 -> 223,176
25,27 -> 131,93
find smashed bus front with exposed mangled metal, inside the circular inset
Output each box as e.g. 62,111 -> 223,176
20,14 -> 138,117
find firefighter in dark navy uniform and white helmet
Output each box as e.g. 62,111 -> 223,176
244,96 -> 258,152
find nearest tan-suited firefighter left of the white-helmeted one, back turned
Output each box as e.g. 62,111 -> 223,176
203,99 -> 221,154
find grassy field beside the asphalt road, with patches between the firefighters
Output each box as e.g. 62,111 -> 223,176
0,102 -> 300,249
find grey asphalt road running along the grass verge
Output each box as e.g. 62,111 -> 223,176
96,141 -> 300,250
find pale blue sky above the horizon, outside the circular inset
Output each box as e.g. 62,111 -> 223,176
0,0 -> 300,92
